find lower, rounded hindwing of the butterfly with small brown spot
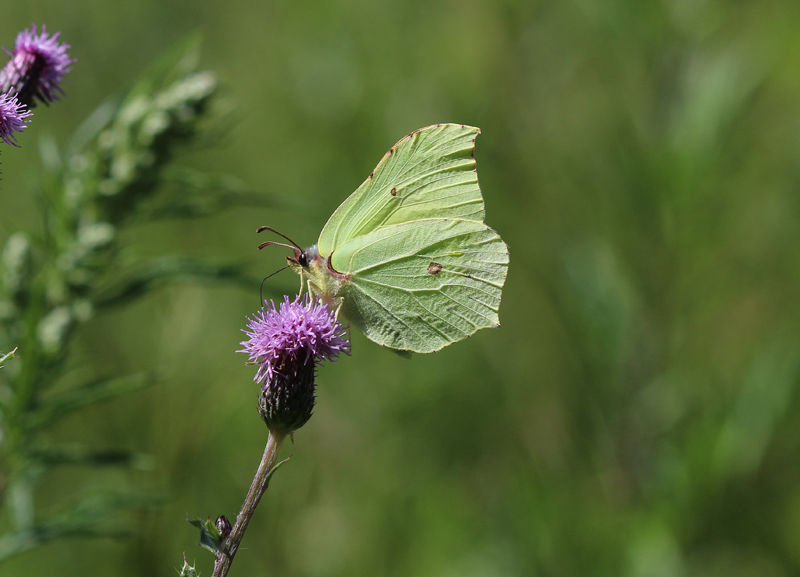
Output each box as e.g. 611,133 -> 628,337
330,218 -> 508,353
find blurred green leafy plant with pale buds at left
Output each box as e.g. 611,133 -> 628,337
0,37 -> 263,561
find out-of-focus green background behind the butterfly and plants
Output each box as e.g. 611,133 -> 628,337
0,0 -> 800,577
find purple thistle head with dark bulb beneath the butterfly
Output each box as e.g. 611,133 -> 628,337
236,294 -> 350,433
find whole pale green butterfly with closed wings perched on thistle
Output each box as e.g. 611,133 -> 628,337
259,124 -> 508,353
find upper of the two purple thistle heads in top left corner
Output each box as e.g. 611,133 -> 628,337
0,24 -> 75,108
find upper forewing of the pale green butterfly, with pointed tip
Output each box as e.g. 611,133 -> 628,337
317,124 -> 484,256
